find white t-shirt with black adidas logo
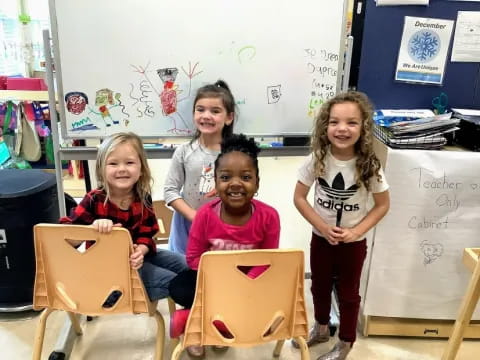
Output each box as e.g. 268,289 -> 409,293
298,151 -> 388,240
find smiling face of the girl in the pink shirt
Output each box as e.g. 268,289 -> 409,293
215,151 -> 258,214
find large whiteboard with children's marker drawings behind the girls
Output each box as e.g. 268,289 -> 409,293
50,0 -> 346,138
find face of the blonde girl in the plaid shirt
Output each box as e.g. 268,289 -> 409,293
105,143 -> 142,193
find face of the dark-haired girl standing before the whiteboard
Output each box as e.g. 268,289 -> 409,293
193,98 -> 233,135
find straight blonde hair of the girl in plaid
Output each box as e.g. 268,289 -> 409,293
95,132 -> 153,208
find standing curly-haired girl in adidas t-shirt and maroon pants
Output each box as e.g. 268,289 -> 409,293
293,91 -> 390,360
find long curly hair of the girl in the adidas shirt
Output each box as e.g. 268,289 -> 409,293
311,91 -> 381,190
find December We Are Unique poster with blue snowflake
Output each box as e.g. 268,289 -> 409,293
395,16 -> 454,85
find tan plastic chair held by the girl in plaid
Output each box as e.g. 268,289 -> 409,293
33,224 -> 165,360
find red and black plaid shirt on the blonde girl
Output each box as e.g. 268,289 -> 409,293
60,189 -> 158,254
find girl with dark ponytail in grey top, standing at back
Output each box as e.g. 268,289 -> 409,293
164,80 -> 235,254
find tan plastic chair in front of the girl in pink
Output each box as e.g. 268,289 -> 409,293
171,250 -> 310,360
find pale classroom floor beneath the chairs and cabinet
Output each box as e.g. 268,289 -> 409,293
0,292 -> 480,360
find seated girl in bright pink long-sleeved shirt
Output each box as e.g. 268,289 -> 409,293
170,134 -> 280,356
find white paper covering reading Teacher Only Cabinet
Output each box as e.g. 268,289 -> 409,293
364,149 -> 480,320
